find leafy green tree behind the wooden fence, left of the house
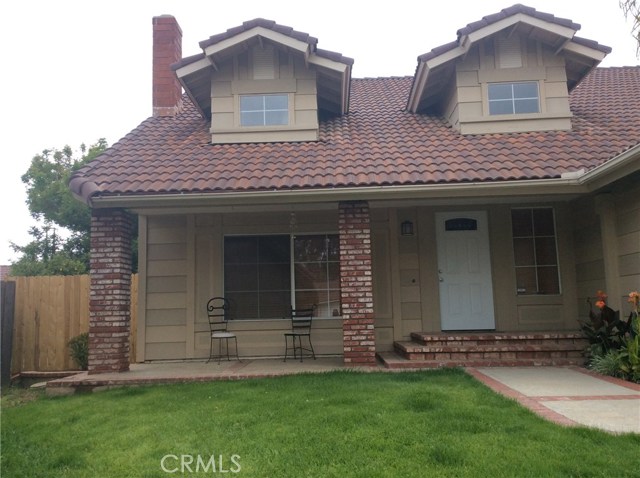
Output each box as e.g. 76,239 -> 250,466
11,138 -> 108,276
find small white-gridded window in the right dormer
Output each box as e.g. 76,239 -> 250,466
487,81 -> 540,116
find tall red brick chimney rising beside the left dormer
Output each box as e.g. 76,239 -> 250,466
153,15 -> 182,116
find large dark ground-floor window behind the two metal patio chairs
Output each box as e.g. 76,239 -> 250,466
224,234 -> 340,319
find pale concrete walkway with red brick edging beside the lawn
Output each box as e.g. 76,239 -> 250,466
467,367 -> 640,433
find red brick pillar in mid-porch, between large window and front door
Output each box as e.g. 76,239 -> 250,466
338,201 -> 376,366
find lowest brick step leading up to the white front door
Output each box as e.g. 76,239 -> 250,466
376,352 -> 584,370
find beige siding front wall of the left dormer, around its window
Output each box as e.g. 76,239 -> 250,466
211,51 -> 318,143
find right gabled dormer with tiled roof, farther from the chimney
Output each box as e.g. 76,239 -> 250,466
407,5 -> 611,134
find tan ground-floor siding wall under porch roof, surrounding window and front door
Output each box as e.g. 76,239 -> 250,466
139,193 -> 604,360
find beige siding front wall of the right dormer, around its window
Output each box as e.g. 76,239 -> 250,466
444,35 -> 571,134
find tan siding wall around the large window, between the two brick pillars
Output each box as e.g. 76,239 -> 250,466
138,209 -> 342,361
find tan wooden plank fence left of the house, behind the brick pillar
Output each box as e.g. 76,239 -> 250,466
8,274 -> 138,374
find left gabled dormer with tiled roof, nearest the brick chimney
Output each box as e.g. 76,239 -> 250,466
172,18 -> 353,143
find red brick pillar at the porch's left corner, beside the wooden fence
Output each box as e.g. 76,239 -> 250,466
89,209 -> 132,374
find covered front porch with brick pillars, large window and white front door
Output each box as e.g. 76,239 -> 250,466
85,180 -> 636,373
